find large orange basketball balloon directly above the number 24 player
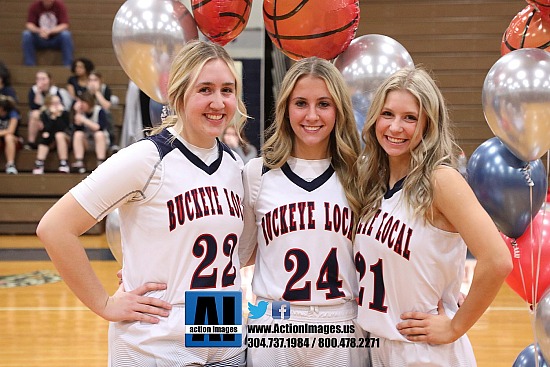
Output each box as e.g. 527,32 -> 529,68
263,0 -> 359,60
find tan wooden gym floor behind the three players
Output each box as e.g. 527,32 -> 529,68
0,236 -> 534,367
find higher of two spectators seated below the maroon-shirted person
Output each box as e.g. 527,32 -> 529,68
25,70 -> 67,150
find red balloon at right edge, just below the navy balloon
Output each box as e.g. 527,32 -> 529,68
501,204 -> 550,304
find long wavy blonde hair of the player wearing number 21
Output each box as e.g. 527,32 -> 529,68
358,67 -> 460,220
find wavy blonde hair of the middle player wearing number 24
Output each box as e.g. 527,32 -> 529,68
262,57 -> 361,215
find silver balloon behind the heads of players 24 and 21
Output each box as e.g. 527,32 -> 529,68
334,34 -> 414,131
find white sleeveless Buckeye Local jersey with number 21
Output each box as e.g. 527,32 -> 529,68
355,184 -> 466,342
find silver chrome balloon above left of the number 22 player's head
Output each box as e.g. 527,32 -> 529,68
112,0 -> 198,103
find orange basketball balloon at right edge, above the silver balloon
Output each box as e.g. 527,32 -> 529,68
500,5 -> 550,56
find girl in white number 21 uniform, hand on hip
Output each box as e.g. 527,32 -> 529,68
355,68 -> 512,366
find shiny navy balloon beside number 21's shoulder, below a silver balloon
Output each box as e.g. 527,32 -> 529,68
467,137 -> 547,238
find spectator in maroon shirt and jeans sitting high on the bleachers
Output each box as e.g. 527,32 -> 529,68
22,0 -> 74,66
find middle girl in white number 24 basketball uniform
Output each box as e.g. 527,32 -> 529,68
239,57 -> 364,367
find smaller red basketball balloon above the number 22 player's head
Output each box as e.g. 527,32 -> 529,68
191,0 -> 252,46
